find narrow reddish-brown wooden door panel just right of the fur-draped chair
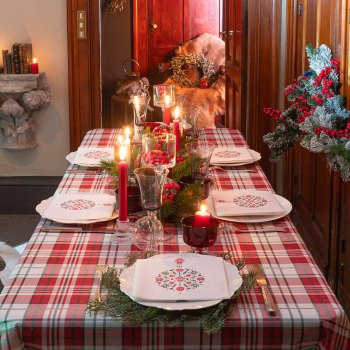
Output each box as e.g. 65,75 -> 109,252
225,0 -> 245,130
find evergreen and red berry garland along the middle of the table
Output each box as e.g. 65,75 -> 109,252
100,127 -> 203,224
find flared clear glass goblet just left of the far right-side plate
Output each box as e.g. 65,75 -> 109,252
185,141 -> 215,181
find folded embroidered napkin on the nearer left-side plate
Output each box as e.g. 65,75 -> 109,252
43,193 -> 115,221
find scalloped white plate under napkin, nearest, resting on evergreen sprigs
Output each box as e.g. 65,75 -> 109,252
119,253 -> 243,310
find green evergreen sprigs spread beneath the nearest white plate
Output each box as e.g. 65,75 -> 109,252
87,251 -> 256,334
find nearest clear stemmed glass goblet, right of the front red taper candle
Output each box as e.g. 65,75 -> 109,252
132,168 -> 169,250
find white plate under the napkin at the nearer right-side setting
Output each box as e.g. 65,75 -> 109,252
204,194 -> 293,224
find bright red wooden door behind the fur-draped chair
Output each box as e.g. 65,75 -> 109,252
133,0 -> 223,85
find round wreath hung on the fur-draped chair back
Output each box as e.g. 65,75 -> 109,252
170,52 -> 217,89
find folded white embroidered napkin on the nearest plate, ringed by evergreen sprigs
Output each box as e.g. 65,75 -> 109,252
133,254 -> 230,301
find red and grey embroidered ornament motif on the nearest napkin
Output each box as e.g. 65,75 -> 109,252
156,258 -> 205,294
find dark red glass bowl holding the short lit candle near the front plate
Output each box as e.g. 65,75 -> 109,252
181,215 -> 220,253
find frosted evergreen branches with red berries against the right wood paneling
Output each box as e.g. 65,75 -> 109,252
263,45 -> 350,181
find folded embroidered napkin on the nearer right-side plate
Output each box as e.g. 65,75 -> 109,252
212,190 -> 284,216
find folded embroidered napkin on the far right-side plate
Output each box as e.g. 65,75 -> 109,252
210,147 -> 254,164
